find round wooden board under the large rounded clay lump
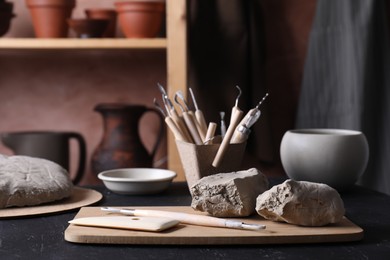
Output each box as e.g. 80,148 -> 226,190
0,187 -> 103,219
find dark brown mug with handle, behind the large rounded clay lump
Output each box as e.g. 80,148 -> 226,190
1,131 -> 86,184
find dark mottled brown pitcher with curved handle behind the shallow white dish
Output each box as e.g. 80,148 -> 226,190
91,103 -> 163,175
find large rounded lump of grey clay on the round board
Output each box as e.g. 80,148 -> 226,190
0,155 -> 73,208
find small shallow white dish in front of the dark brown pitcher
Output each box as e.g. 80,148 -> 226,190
98,168 -> 177,195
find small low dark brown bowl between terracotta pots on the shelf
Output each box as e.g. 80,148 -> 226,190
68,18 -> 109,38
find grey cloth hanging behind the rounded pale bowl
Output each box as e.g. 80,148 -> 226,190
296,0 -> 390,194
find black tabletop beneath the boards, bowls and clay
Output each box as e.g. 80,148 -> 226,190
0,180 -> 390,260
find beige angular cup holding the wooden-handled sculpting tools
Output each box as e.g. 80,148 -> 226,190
176,140 -> 246,189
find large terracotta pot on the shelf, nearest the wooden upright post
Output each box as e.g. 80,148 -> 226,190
115,1 -> 165,38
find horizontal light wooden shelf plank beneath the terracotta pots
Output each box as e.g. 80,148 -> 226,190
0,38 -> 167,50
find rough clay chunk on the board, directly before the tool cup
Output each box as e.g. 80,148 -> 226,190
191,168 -> 268,217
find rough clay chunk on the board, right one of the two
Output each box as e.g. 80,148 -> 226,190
256,180 -> 345,226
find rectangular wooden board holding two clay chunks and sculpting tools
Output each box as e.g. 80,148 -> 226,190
65,207 -> 363,245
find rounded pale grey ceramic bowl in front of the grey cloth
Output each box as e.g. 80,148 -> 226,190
280,129 -> 369,190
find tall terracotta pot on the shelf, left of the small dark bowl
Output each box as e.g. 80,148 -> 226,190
26,0 -> 76,38
